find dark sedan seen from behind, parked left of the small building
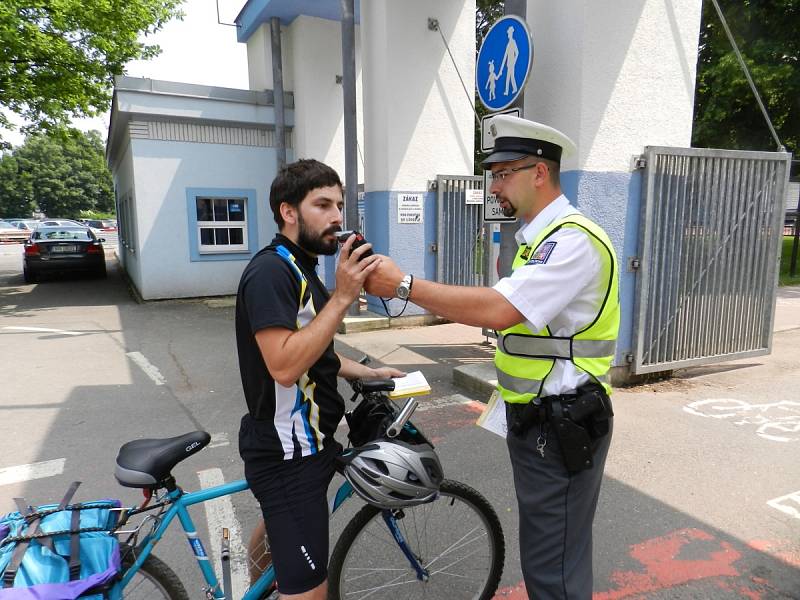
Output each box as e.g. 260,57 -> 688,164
23,225 -> 106,283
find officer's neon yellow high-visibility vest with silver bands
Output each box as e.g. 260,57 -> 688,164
495,214 -> 619,404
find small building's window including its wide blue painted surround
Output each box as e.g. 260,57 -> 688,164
186,188 -> 258,262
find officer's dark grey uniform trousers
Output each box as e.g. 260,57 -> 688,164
506,419 -> 613,600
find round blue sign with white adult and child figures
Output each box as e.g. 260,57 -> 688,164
475,15 -> 533,111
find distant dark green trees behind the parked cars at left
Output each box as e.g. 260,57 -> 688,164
0,129 -> 114,218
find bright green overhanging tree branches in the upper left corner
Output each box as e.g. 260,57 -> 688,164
0,0 -> 182,148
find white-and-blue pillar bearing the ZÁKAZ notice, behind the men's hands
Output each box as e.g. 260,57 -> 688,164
361,0 -> 475,314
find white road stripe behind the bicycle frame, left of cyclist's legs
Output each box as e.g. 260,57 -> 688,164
197,469 -> 250,598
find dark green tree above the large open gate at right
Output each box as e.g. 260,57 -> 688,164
692,0 -> 800,154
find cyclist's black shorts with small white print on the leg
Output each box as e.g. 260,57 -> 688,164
239,416 -> 341,594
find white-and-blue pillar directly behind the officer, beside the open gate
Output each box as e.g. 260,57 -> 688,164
525,0 -> 702,365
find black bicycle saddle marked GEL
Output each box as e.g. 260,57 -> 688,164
114,431 -> 211,488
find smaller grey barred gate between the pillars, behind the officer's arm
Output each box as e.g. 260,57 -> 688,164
436,175 -> 484,285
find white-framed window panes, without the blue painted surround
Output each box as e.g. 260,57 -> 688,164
195,196 -> 248,254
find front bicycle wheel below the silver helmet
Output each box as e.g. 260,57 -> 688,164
328,480 -> 505,600
